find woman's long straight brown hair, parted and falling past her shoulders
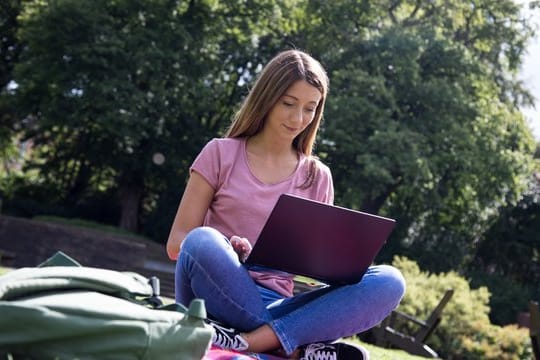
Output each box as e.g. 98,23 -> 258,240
225,50 -> 328,156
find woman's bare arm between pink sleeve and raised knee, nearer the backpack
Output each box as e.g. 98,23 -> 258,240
167,171 -> 214,260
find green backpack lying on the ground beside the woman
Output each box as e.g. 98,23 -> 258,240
0,252 -> 212,360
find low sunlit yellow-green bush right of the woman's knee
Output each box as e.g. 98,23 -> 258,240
393,257 -> 531,359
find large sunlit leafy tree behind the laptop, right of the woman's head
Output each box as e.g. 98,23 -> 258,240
306,0 -> 534,271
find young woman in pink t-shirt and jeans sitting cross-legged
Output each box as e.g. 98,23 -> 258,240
167,50 -> 405,359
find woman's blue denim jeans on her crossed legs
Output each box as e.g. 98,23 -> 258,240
175,227 -> 405,354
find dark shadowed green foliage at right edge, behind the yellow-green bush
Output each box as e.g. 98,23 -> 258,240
467,170 -> 540,325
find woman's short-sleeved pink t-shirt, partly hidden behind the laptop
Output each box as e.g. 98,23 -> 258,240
191,138 -> 334,296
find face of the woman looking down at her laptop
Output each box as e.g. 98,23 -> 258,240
264,80 -> 322,142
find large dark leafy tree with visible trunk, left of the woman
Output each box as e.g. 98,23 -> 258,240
10,0 -> 300,230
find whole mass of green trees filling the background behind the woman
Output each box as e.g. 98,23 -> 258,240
0,0 -> 540,359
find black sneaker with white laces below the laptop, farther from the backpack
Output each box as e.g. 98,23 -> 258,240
300,342 -> 369,360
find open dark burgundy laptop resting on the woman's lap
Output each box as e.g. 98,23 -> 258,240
245,194 -> 395,285
